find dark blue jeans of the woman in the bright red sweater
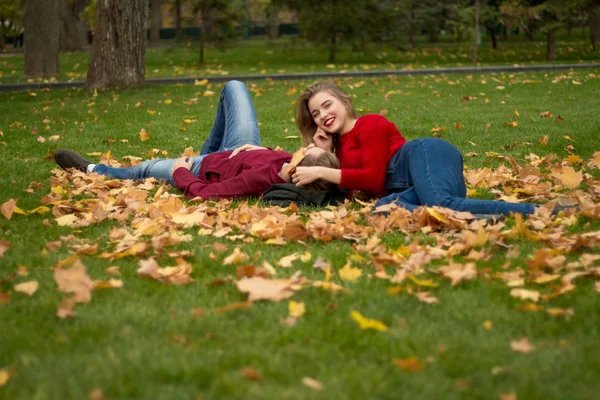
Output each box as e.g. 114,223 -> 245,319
375,138 -> 536,215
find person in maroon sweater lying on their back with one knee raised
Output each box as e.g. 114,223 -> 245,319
54,81 -> 339,198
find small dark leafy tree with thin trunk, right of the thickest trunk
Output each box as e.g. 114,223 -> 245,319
194,0 -> 243,64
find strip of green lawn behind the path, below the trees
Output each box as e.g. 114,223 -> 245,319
0,38 -> 599,84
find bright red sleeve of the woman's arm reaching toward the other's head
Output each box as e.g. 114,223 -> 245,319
340,118 -> 390,193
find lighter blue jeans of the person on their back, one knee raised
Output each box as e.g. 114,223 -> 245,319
93,81 -> 260,185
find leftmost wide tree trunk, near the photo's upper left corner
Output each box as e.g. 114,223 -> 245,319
25,0 -> 60,76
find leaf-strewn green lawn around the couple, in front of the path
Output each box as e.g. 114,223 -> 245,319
0,69 -> 600,399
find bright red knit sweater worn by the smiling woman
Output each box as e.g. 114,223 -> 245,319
336,114 -> 406,197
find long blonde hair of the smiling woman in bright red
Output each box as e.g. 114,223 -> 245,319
296,81 -> 358,146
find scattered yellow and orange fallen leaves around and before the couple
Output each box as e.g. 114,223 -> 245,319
0,148 -> 600,324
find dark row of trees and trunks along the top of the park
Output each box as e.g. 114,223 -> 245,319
0,0 -> 600,90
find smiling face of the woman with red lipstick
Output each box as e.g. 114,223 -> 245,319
308,91 -> 354,134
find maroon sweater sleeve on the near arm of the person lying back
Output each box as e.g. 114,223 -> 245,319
173,165 -> 283,199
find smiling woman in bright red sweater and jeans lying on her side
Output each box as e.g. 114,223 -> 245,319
292,82 -> 536,215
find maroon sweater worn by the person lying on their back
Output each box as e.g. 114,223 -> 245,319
173,150 -> 292,199
